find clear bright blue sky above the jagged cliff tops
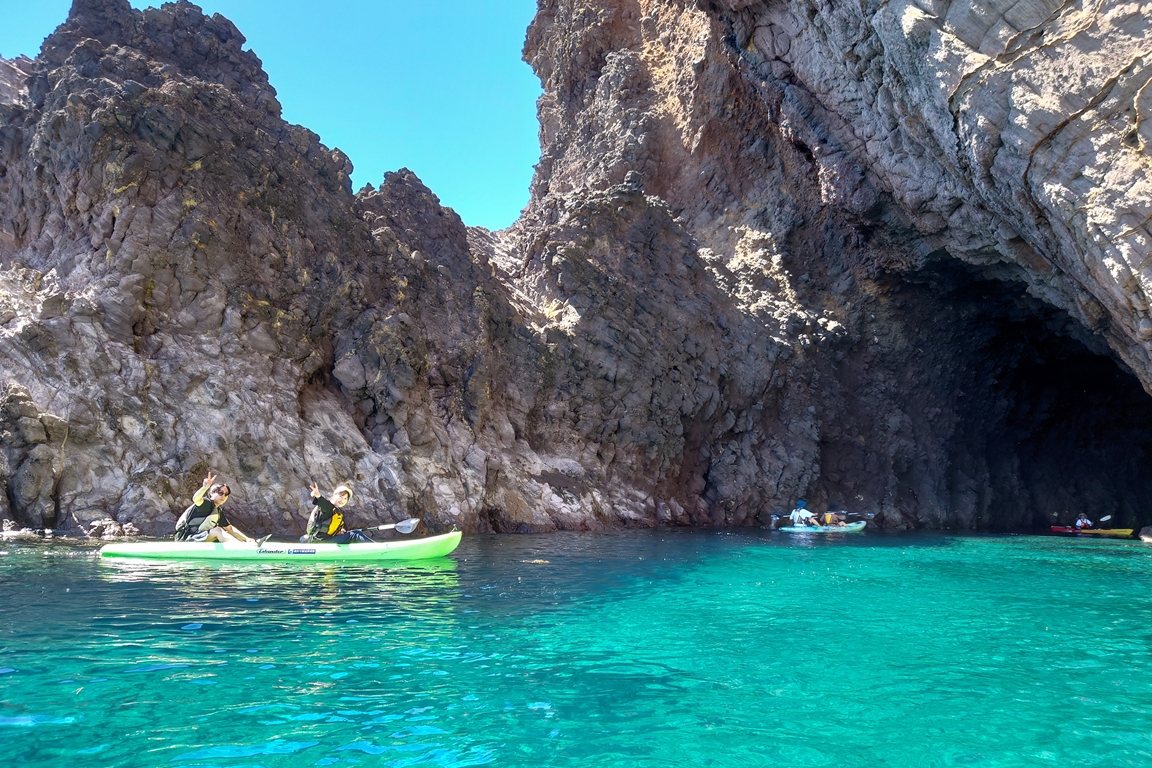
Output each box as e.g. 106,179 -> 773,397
0,0 -> 540,229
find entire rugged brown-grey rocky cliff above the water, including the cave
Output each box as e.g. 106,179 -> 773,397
0,0 -> 1152,533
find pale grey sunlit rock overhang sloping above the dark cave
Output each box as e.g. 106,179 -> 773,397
719,0 -> 1152,370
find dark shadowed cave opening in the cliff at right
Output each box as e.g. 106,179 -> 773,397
894,259 -> 1152,531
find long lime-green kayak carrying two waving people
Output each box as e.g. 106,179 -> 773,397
100,531 -> 463,563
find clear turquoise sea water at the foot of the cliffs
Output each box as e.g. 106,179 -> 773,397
0,532 -> 1152,768
